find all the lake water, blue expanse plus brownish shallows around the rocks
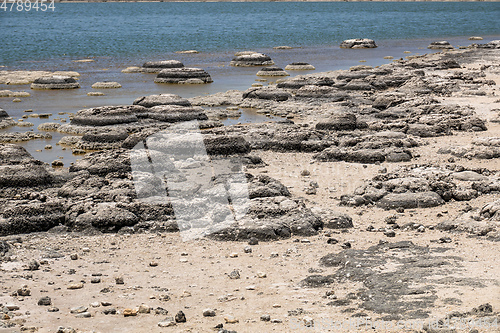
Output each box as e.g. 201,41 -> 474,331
0,2 -> 500,162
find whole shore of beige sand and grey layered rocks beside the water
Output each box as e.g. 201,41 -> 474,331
0,49 -> 500,333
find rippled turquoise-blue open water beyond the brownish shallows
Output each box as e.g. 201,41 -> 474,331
0,2 -> 500,65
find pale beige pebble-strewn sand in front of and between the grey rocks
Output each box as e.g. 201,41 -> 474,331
0,46 -> 500,333
